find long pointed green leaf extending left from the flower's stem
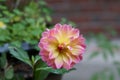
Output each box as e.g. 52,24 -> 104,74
9,47 -> 33,67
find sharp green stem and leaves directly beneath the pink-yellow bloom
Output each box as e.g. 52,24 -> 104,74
9,47 -> 75,80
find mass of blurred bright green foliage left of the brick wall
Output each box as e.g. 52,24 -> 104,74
0,0 -> 51,48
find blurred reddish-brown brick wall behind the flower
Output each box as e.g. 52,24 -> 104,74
46,0 -> 120,32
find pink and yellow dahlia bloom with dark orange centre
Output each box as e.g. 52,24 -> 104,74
38,24 -> 86,69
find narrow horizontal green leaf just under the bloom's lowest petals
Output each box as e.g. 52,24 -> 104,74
37,67 -> 76,74
